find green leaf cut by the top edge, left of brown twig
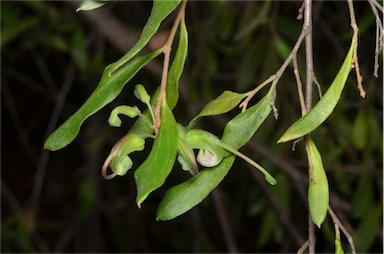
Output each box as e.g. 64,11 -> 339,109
109,0 -> 181,75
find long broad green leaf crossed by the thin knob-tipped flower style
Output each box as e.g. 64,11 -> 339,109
157,88 -> 274,220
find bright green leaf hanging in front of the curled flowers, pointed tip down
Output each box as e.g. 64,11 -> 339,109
135,102 -> 178,207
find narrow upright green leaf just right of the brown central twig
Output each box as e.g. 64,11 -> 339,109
166,19 -> 188,109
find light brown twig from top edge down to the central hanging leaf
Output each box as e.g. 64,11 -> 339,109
153,0 -> 187,133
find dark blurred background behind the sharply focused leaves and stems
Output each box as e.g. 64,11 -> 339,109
1,1 -> 383,253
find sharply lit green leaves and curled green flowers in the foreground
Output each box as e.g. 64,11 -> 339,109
44,0 -> 372,252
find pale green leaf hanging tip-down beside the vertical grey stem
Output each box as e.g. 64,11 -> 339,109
308,138 -> 329,228
